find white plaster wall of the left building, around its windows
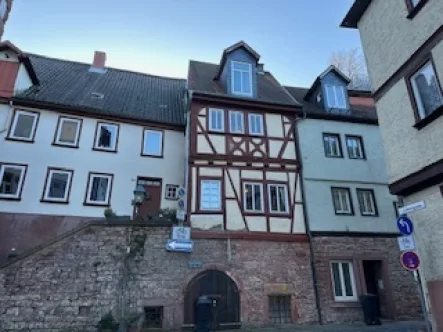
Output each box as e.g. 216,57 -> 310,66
0,105 -> 185,217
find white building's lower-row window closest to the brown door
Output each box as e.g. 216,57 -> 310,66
85,173 -> 114,206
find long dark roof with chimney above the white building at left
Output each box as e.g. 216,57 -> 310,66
15,54 -> 186,126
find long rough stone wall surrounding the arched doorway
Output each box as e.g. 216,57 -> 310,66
0,225 -> 317,331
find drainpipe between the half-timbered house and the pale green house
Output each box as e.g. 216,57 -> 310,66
294,111 -> 323,325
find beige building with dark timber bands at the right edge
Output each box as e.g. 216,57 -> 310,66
342,0 -> 443,331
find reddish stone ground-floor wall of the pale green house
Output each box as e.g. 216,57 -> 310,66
314,236 -> 421,323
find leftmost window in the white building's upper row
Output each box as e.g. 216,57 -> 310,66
8,110 -> 39,142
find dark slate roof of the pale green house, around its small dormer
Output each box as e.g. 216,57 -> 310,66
285,86 -> 377,123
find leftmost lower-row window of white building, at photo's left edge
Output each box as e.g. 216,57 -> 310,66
0,164 -> 27,200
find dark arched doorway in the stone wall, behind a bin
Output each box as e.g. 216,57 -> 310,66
184,270 -> 240,329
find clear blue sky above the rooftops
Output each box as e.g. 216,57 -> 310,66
3,0 -> 360,86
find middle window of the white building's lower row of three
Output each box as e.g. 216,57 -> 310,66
42,168 -> 73,203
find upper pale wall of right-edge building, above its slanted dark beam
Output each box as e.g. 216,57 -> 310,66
358,0 -> 443,90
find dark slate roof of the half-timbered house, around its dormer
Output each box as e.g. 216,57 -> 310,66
188,60 -> 301,106
